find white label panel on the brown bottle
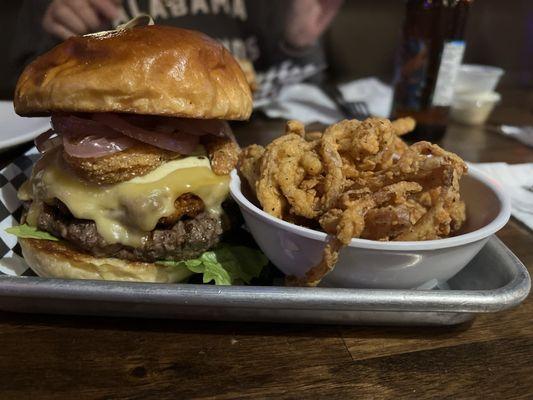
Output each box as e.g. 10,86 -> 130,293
431,40 -> 465,107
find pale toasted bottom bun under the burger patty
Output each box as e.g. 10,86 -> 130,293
19,239 -> 192,283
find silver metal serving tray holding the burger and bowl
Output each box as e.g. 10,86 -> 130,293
0,237 -> 531,325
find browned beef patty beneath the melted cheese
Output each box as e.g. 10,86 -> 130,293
32,205 -> 223,262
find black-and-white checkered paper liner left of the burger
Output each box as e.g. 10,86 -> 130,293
0,147 -> 39,276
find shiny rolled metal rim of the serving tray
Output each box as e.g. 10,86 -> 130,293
0,238 -> 531,313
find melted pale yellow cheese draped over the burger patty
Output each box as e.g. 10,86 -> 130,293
24,152 -> 229,247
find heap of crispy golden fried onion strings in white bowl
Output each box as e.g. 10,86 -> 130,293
239,118 -> 467,286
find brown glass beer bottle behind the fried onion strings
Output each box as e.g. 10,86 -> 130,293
392,0 -> 473,141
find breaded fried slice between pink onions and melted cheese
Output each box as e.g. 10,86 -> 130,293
63,144 -> 179,184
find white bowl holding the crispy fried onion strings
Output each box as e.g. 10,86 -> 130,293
230,168 -> 511,289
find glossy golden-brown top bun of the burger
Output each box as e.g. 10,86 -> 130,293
14,25 -> 252,120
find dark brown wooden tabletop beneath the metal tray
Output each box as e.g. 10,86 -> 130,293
0,91 -> 533,399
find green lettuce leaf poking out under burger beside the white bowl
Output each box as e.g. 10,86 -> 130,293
157,244 -> 268,285
